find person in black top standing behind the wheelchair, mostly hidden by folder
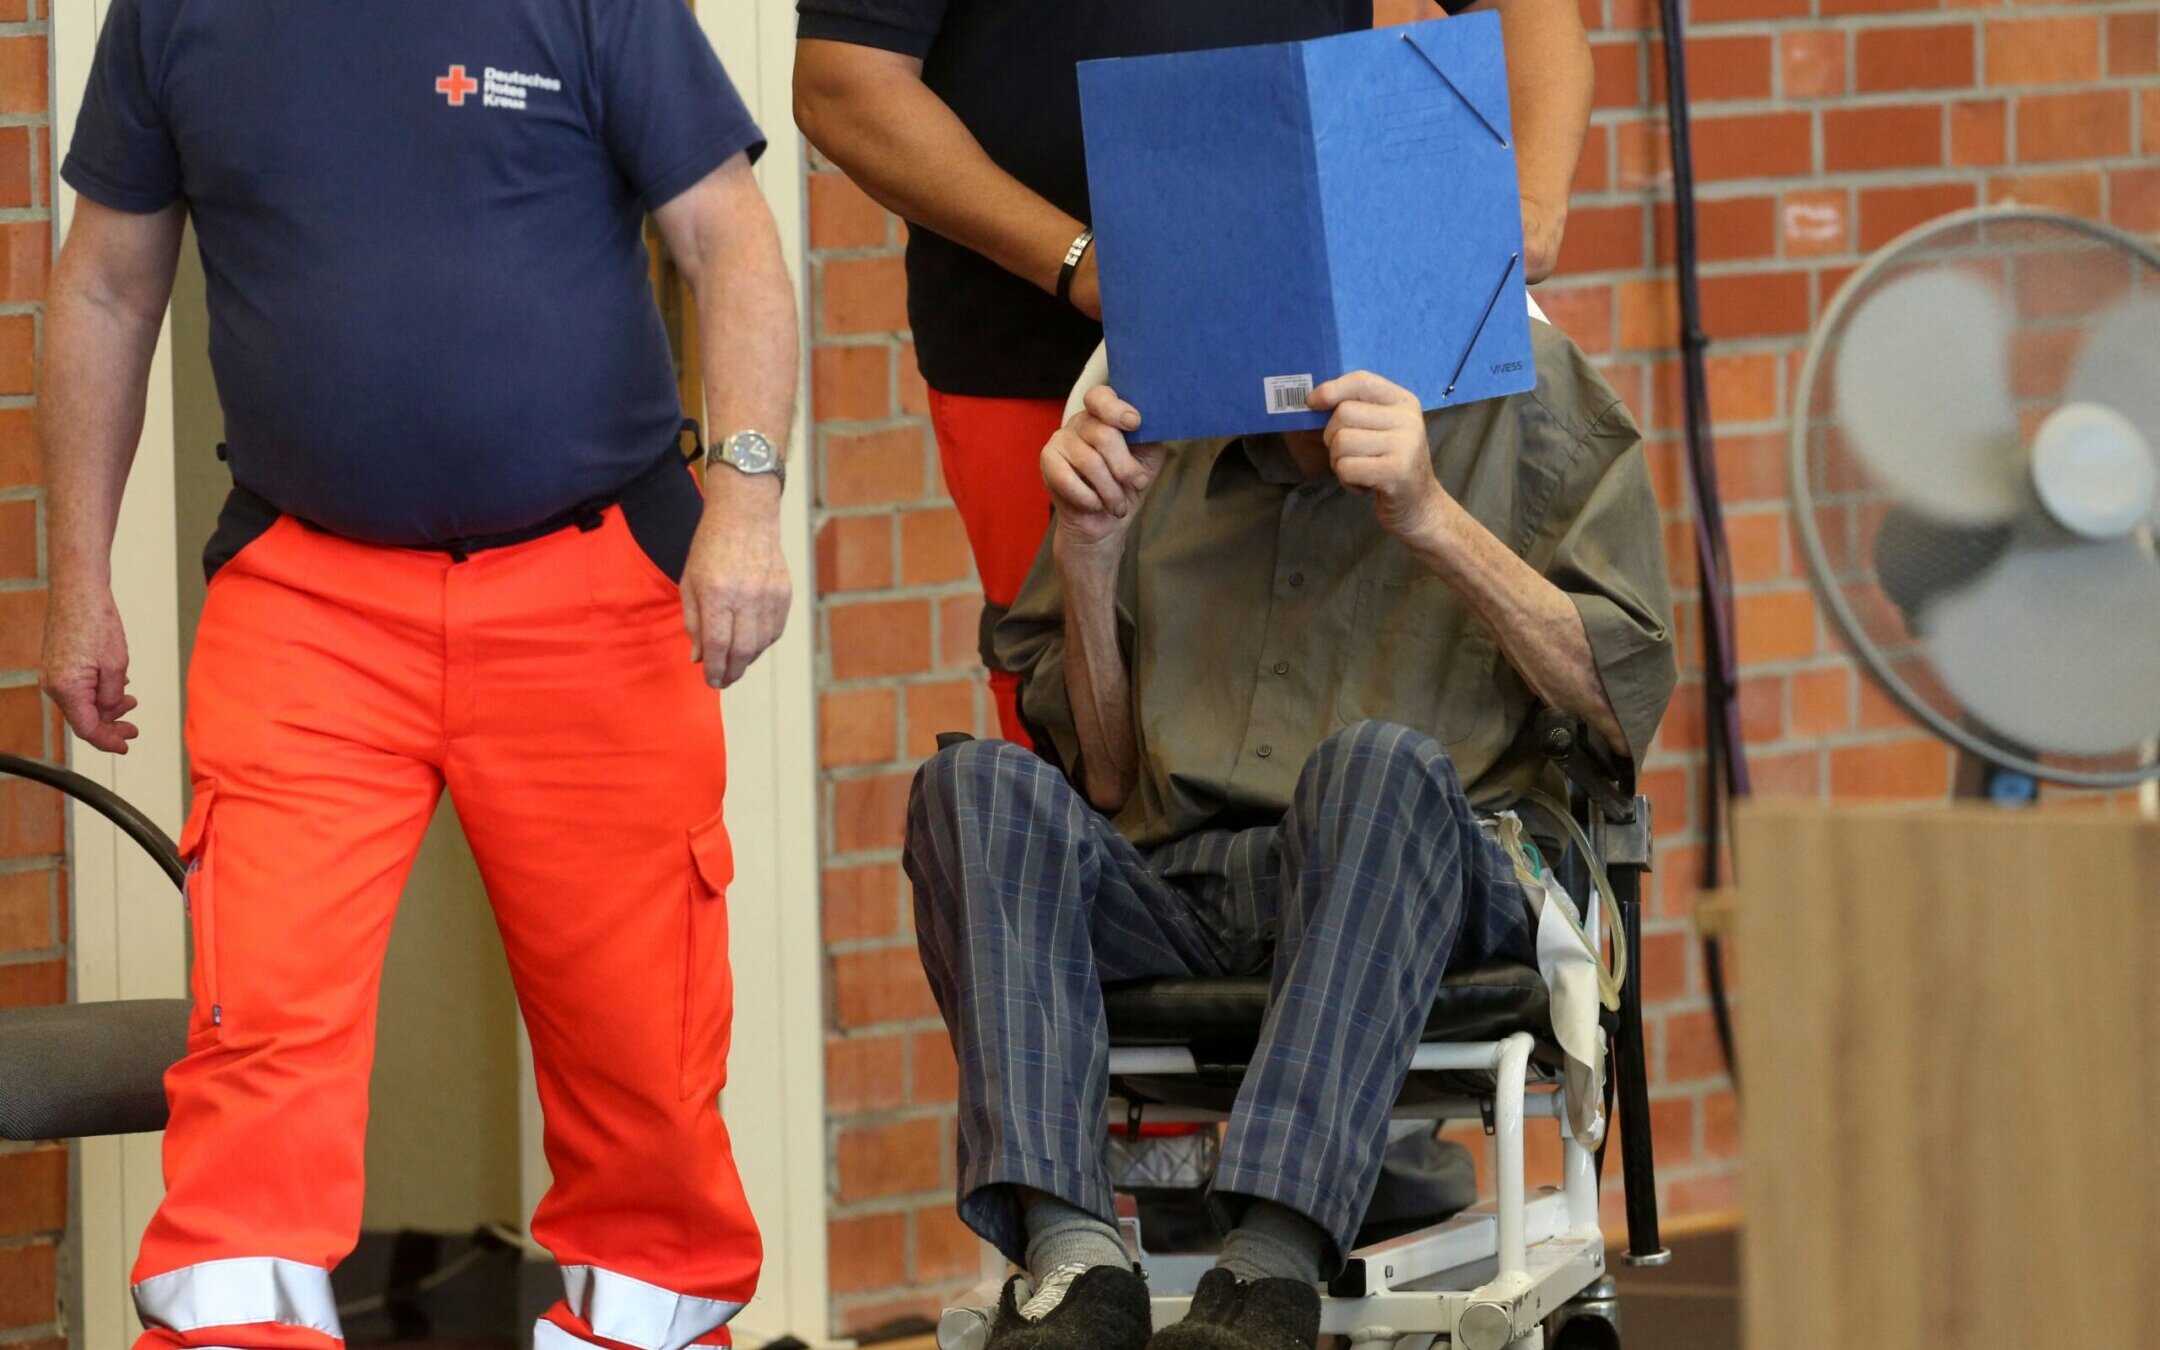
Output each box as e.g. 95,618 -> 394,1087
795,0 -> 1592,741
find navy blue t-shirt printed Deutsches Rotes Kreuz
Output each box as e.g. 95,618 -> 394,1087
60,0 -> 765,544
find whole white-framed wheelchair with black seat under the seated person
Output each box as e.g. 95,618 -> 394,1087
937,708 -> 1672,1350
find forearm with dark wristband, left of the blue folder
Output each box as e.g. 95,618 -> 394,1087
795,39 -> 1080,292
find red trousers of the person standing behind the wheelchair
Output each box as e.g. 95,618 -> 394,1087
931,389 -> 1065,745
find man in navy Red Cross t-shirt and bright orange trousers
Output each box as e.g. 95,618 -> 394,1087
39,0 -> 797,1350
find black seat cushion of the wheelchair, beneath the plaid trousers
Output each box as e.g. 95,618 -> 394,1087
1104,963 -> 1553,1063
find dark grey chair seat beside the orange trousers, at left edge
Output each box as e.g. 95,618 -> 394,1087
0,998 -> 188,1140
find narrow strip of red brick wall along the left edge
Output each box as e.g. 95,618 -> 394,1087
0,0 -> 67,1350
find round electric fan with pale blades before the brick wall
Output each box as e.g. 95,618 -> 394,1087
1791,207 -> 2160,788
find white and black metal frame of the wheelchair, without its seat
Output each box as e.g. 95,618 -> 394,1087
937,708 -> 1672,1350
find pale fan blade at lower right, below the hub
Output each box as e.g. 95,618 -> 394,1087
1927,540 -> 2160,754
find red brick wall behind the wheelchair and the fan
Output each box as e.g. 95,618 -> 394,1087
810,0 -> 2160,1326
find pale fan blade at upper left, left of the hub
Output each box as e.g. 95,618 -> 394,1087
1836,268 -> 2033,525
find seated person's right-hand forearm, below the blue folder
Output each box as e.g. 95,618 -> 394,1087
1406,499 -> 1626,752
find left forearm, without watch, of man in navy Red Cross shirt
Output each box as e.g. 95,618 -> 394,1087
37,255 -> 162,590
